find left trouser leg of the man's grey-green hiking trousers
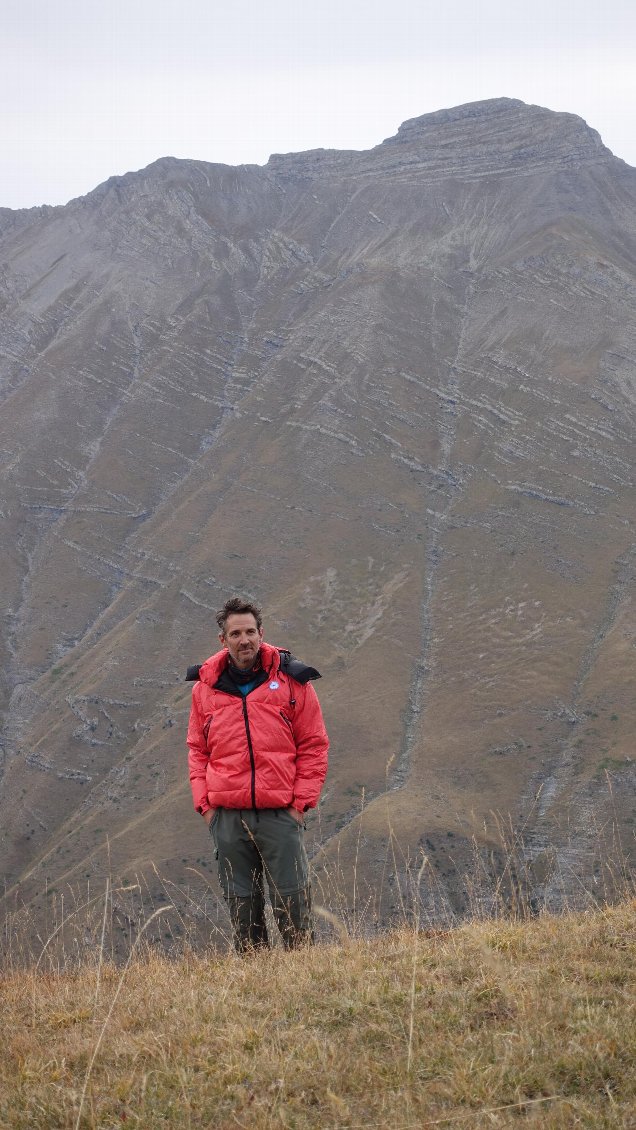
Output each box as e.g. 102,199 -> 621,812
210,808 -> 269,953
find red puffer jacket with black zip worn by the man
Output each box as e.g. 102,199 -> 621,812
188,643 -> 329,812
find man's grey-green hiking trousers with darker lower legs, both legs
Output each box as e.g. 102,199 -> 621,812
210,808 -> 314,953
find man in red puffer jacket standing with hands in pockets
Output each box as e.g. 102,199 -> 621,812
186,597 -> 329,953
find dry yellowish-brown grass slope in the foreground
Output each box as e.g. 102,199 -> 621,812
0,899 -> 636,1130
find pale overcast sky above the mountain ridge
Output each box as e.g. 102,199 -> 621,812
0,0 -> 636,208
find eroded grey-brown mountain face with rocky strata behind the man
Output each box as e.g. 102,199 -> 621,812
0,98 -> 636,935
